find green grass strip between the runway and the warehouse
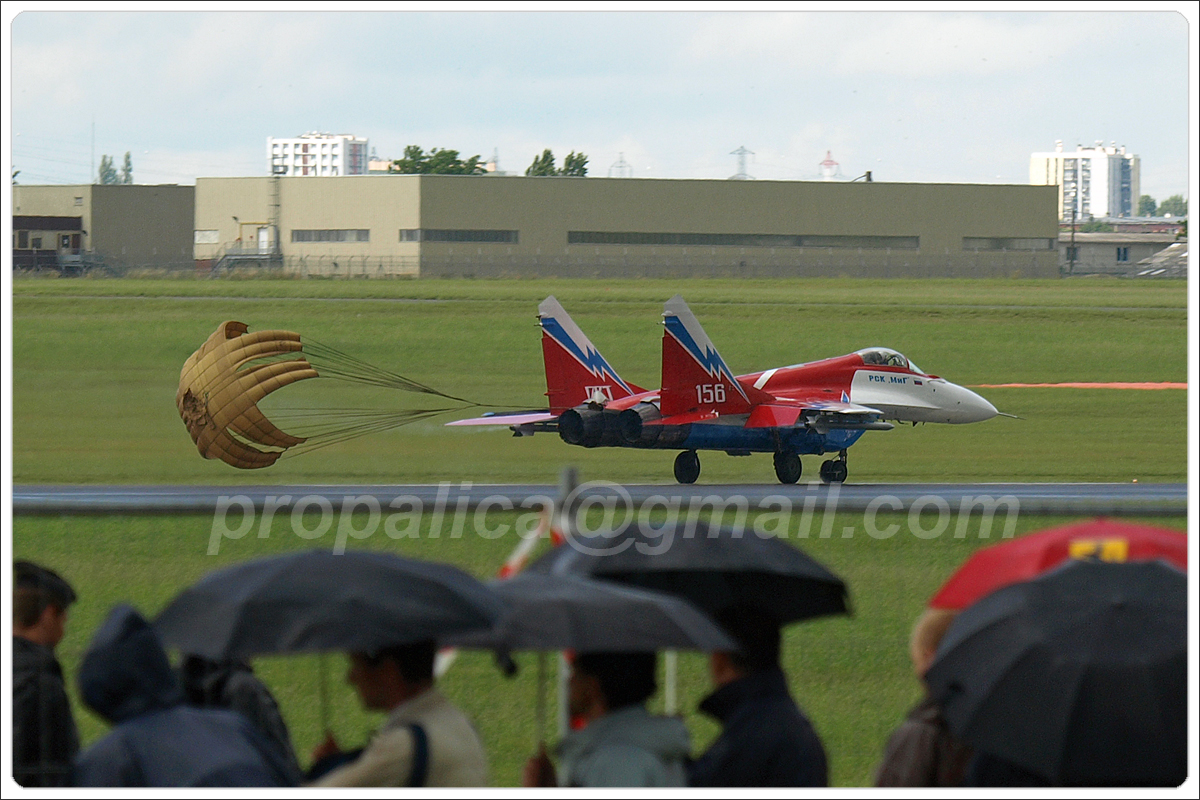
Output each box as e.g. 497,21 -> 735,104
13,281 -> 1187,483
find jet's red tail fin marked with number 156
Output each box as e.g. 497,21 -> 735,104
660,295 -> 760,416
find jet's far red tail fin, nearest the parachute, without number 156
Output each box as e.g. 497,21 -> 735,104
538,295 -> 643,414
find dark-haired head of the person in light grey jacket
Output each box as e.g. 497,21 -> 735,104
568,652 -> 658,720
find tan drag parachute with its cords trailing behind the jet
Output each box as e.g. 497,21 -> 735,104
175,320 -> 480,469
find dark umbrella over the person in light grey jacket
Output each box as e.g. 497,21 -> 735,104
443,573 -> 737,652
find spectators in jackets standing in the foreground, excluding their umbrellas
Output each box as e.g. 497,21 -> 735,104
12,561 -> 1180,788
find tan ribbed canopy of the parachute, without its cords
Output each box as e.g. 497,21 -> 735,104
175,320 -> 318,469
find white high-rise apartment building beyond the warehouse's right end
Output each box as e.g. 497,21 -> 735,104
1030,139 -> 1141,221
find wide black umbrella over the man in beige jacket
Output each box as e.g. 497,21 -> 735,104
155,551 -> 504,660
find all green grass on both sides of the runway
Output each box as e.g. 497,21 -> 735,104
12,279 -> 1187,786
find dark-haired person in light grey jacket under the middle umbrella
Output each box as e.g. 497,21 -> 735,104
522,652 -> 691,788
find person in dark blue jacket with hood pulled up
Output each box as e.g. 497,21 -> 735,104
74,606 -> 300,787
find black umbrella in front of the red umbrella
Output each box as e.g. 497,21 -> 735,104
925,560 -> 1188,786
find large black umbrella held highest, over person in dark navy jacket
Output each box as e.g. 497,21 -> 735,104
528,521 -> 847,622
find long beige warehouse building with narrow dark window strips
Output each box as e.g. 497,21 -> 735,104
191,175 -> 1058,277
